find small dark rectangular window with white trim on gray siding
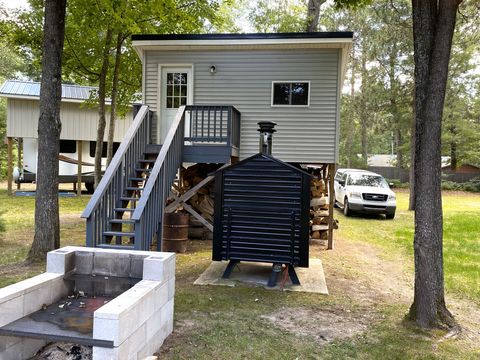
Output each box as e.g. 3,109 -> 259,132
272,81 -> 310,106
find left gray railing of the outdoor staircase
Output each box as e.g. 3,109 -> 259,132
81,105 -> 151,247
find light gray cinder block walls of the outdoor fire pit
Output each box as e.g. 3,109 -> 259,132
0,246 -> 175,360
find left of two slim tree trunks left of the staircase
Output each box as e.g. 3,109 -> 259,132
94,28 -> 112,188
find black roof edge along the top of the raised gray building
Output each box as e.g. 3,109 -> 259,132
132,31 -> 353,41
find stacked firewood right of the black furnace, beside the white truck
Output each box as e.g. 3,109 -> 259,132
310,174 -> 338,240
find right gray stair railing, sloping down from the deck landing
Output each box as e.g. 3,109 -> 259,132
131,106 -> 185,251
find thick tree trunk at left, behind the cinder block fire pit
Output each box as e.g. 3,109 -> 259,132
28,0 -> 66,261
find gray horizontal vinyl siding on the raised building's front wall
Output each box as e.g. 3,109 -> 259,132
144,49 -> 340,163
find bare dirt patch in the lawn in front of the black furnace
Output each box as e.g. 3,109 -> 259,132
261,308 -> 376,345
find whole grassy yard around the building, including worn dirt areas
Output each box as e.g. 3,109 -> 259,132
0,184 -> 480,359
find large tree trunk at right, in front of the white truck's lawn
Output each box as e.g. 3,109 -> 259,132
410,0 -> 461,327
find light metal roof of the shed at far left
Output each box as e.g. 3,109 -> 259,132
0,80 -> 97,102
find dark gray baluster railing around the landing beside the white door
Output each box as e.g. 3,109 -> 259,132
185,105 -> 241,148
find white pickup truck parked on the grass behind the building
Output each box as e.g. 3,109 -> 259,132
334,169 -> 397,219
